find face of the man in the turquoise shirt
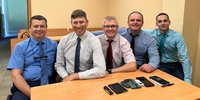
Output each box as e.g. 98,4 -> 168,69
156,15 -> 170,33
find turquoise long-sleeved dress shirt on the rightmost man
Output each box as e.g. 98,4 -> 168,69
146,29 -> 192,83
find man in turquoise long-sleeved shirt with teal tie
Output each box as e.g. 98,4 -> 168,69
148,13 -> 192,83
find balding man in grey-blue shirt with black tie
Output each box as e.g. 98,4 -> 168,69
120,11 -> 160,73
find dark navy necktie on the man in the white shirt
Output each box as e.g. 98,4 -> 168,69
74,38 -> 81,73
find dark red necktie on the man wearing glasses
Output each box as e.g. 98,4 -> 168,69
106,40 -> 113,70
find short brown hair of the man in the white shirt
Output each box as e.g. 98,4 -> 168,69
71,9 -> 87,20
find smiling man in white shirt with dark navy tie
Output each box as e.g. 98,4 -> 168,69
55,9 -> 106,81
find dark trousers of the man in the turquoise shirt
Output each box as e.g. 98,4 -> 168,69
158,62 -> 184,80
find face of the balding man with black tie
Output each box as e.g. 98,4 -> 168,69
128,13 -> 143,31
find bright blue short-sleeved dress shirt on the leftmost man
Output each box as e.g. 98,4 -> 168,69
7,37 -> 57,81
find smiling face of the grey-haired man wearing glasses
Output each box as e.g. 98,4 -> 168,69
103,20 -> 118,39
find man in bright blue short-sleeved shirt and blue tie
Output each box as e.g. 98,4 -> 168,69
7,15 -> 57,100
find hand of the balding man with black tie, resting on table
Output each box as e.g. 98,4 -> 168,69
139,64 -> 155,73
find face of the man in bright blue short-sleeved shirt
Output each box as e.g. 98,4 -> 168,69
30,19 -> 47,40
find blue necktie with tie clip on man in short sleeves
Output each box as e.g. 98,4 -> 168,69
38,42 -> 49,85
